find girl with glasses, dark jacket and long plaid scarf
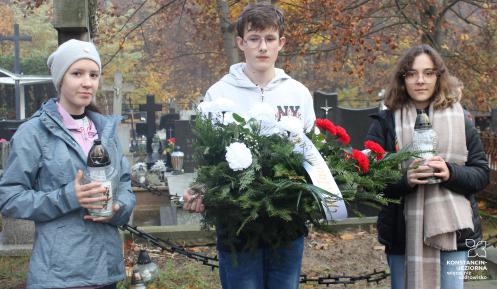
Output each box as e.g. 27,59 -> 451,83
367,45 -> 489,289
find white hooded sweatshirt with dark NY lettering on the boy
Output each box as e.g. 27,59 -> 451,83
204,63 -> 316,131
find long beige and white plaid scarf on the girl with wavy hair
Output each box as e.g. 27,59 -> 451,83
394,103 -> 473,289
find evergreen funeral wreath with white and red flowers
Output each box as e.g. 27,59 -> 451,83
193,99 -> 408,250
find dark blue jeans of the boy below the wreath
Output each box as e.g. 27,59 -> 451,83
218,237 -> 304,289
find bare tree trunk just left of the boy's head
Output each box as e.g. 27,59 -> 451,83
216,0 -> 240,65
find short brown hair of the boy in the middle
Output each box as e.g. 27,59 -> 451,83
236,3 -> 285,38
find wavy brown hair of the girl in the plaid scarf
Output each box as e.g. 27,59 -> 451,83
384,44 -> 459,110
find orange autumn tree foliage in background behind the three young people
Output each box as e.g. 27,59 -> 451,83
4,0 -> 497,111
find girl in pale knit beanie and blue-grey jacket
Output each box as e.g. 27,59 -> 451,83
0,39 -> 135,289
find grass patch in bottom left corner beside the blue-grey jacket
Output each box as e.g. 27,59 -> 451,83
0,256 -> 29,289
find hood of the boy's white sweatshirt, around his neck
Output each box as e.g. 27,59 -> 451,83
221,62 -> 291,90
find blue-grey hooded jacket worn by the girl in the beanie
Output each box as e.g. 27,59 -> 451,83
0,99 -> 135,288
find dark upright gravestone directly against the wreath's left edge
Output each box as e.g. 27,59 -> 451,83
174,120 -> 195,173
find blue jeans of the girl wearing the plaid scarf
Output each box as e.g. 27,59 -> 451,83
387,251 -> 468,289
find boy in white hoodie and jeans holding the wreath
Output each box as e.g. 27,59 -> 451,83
183,3 -> 316,289
